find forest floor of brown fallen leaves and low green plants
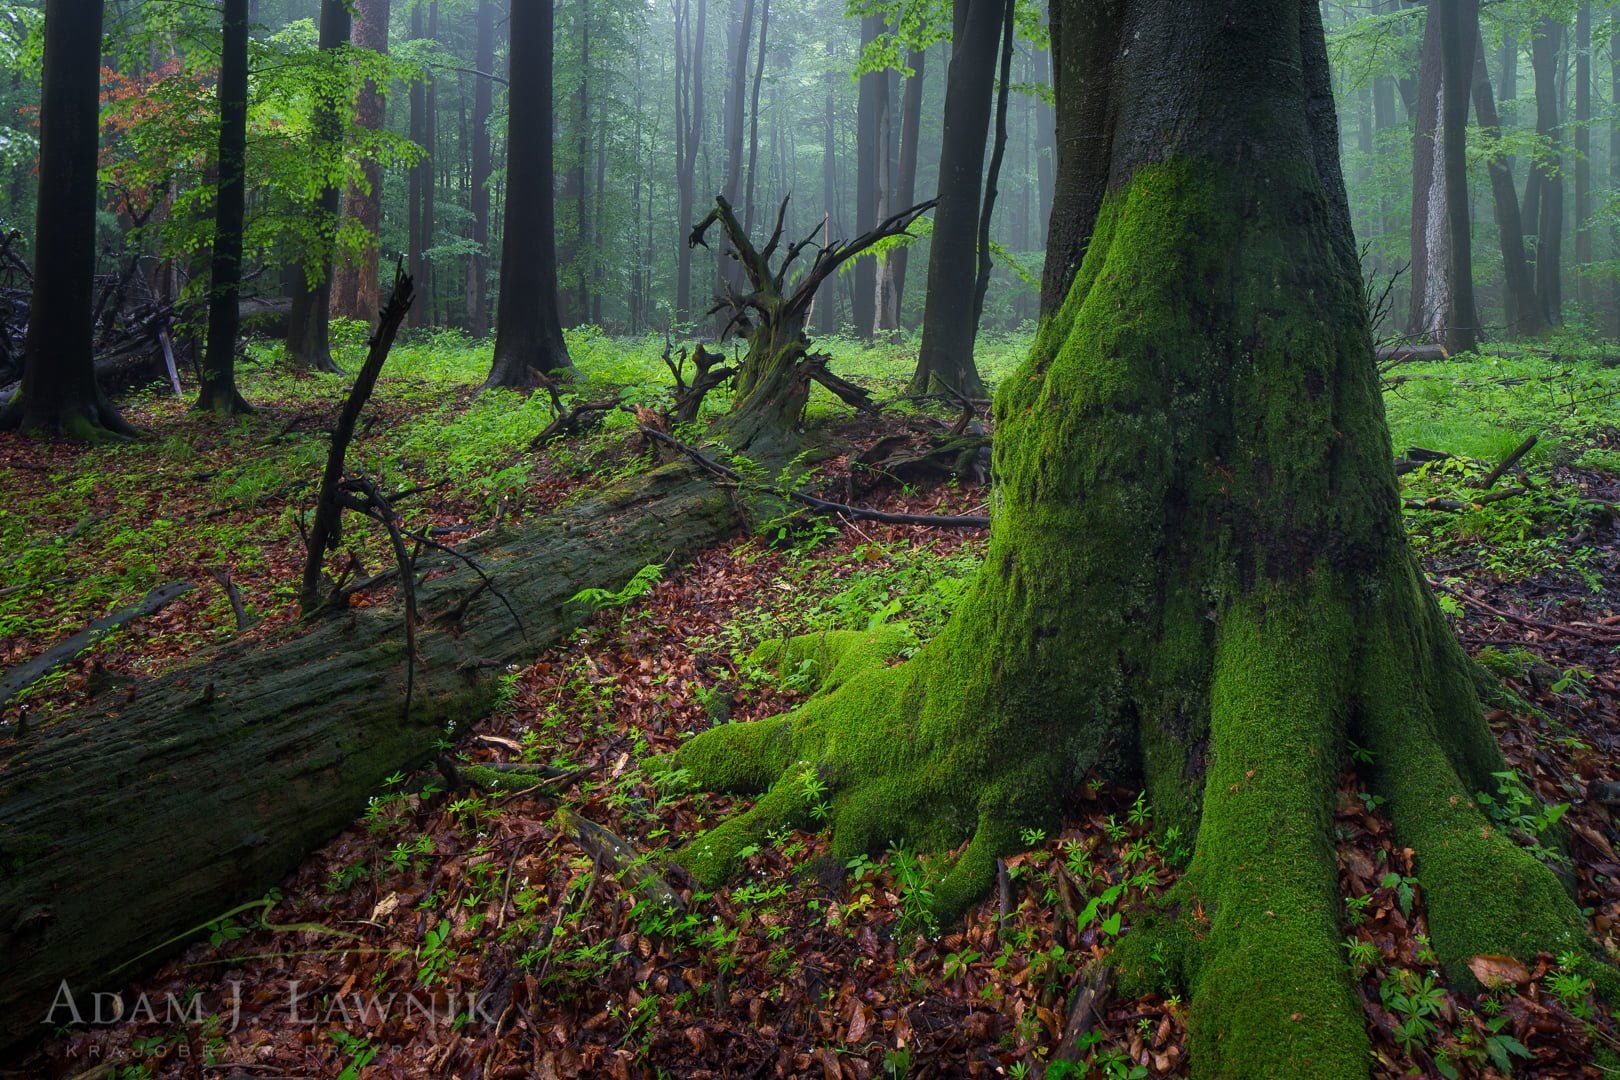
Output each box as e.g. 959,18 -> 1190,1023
0,334 -> 1620,1080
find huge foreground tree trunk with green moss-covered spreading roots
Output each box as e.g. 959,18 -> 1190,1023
677,0 -> 1605,1077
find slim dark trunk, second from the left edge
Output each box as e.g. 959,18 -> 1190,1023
198,0 -> 253,416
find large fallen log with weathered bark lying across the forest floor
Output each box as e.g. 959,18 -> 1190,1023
0,465 -> 735,1044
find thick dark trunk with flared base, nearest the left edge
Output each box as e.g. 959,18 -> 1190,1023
0,0 -> 134,437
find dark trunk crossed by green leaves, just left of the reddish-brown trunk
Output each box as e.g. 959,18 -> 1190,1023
287,0 -> 348,372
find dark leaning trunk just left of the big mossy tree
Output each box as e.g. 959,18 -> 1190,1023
910,0 -> 1008,397
